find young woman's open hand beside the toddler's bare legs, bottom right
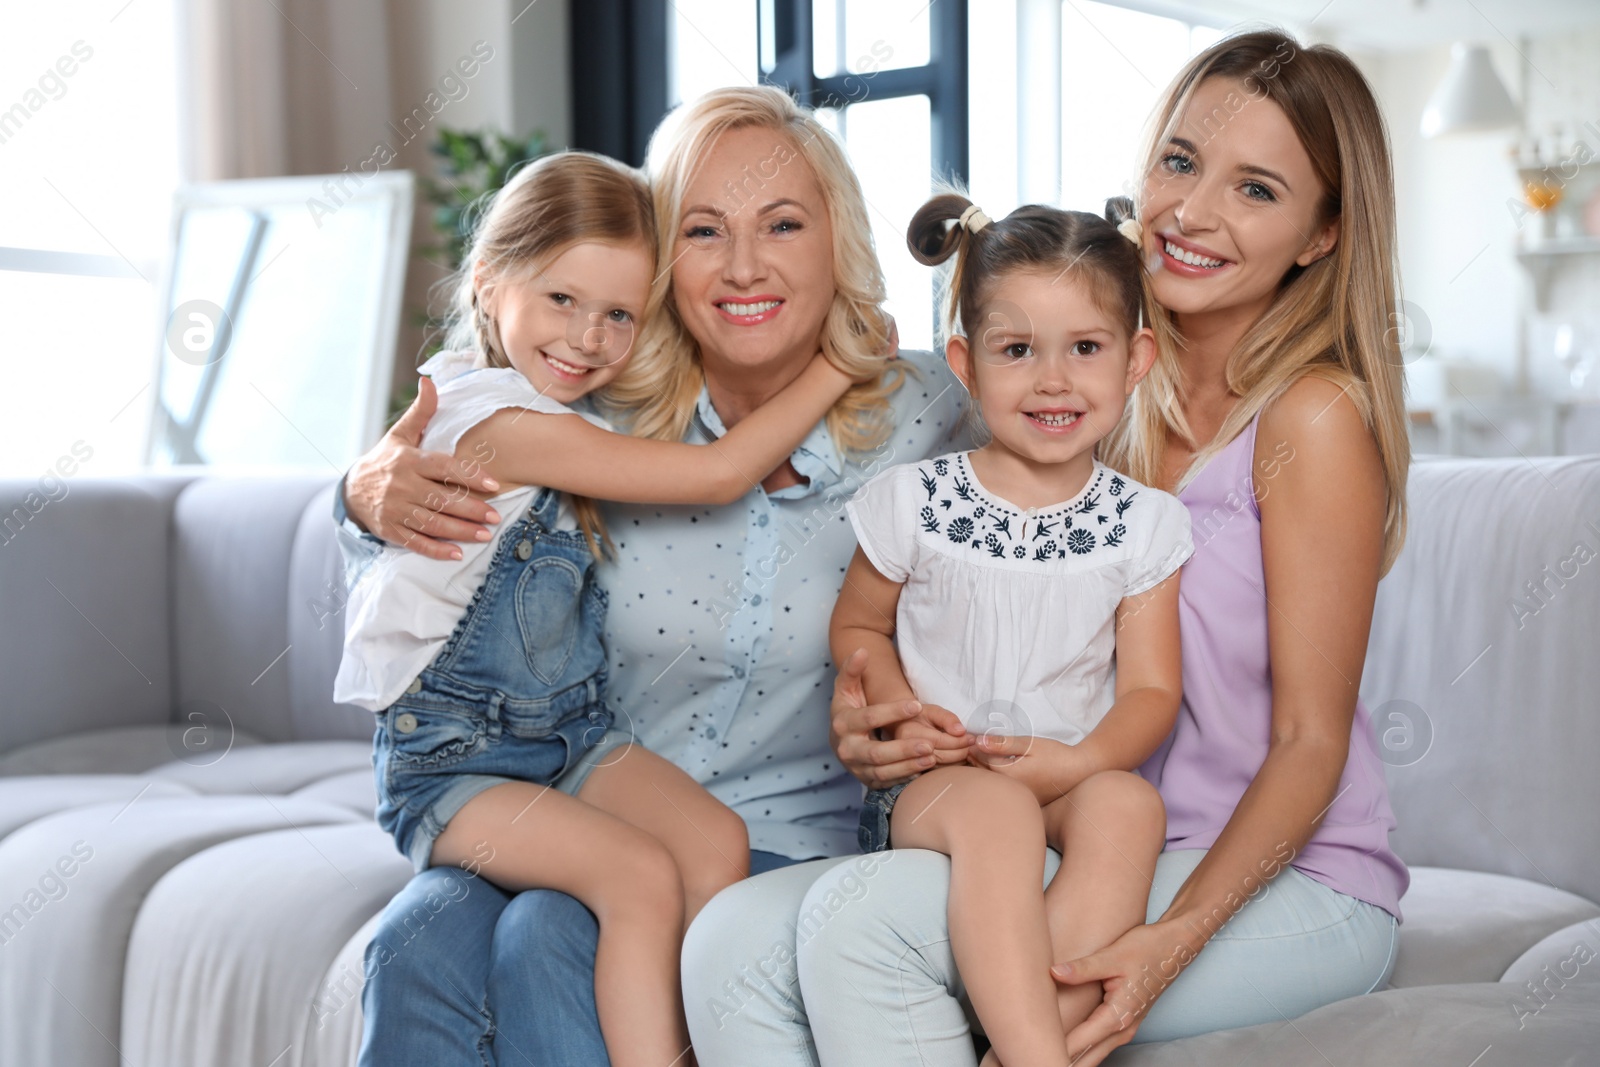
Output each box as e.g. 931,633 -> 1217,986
1050,921 -> 1203,1067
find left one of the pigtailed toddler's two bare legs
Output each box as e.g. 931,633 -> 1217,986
890,766 -> 1067,1067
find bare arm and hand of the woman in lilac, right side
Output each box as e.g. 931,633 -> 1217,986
1056,378 -> 1386,1064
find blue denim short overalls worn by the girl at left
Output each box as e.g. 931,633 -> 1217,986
373,488 -> 626,870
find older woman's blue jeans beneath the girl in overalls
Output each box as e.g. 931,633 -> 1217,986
358,851 -> 798,1067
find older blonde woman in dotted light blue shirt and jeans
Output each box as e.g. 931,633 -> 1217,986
342,88 -> 965,1067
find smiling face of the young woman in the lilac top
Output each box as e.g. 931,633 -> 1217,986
1144,77 -> 1339,317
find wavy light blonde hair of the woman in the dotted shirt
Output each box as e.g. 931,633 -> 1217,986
605,86 -> 910,453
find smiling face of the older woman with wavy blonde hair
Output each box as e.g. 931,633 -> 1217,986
672,126 -> 834,374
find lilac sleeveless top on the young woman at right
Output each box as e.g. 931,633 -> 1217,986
1141,413 -> 1410,918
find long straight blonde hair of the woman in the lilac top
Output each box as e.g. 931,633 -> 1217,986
1101,30 -> 1411,574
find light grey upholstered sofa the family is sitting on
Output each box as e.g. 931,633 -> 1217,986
0,456 -> 1600,1067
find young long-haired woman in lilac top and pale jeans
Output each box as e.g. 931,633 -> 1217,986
683,34 -> 1410,1067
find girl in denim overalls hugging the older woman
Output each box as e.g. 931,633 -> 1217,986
334,152 -> 853,1065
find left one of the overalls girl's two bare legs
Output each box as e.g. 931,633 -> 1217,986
432,782 -> 690,1067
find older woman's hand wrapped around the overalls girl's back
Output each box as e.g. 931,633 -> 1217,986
344,378 -> 499,560
